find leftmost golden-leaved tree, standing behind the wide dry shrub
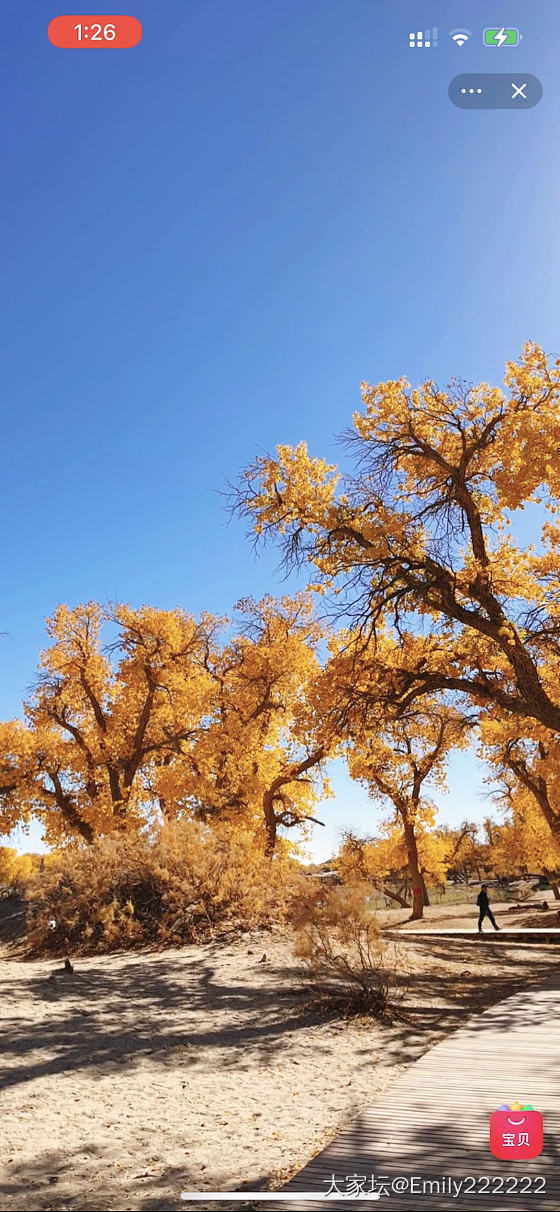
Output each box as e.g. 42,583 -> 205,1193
0,602 -> 218,842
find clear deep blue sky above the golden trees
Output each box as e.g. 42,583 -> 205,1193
0,0 -> 560,857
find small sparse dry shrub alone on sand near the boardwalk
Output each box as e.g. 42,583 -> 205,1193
292,881 -> 404,1014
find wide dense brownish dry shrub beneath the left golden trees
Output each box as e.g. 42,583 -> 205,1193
28,821 -> 299,954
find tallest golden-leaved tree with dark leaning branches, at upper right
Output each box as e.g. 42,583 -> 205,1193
235,344 -> 560,736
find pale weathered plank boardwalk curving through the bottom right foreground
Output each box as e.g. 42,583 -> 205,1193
266,974 -> 560,1212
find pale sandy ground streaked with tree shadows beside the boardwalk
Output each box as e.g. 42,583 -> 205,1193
0,907 -> 560,1212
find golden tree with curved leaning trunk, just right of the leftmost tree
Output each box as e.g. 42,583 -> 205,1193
166,594 -> 333,856
